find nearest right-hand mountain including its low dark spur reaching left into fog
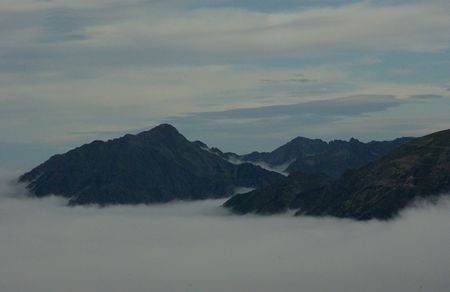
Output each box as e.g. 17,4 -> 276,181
224,130 -> 450,220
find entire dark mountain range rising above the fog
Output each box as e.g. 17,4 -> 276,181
19,124 -> 450,220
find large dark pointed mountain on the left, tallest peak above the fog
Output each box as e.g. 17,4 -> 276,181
19,124 -> 282,205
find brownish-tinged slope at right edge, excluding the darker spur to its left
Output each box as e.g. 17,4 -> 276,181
299,130 -> 450,220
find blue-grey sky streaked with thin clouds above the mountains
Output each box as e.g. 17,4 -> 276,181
0,0 -> 450,169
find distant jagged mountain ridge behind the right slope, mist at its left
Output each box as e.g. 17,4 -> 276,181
240,137 -> 412,177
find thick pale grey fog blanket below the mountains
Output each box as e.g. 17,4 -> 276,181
0,173 -> 450,292
